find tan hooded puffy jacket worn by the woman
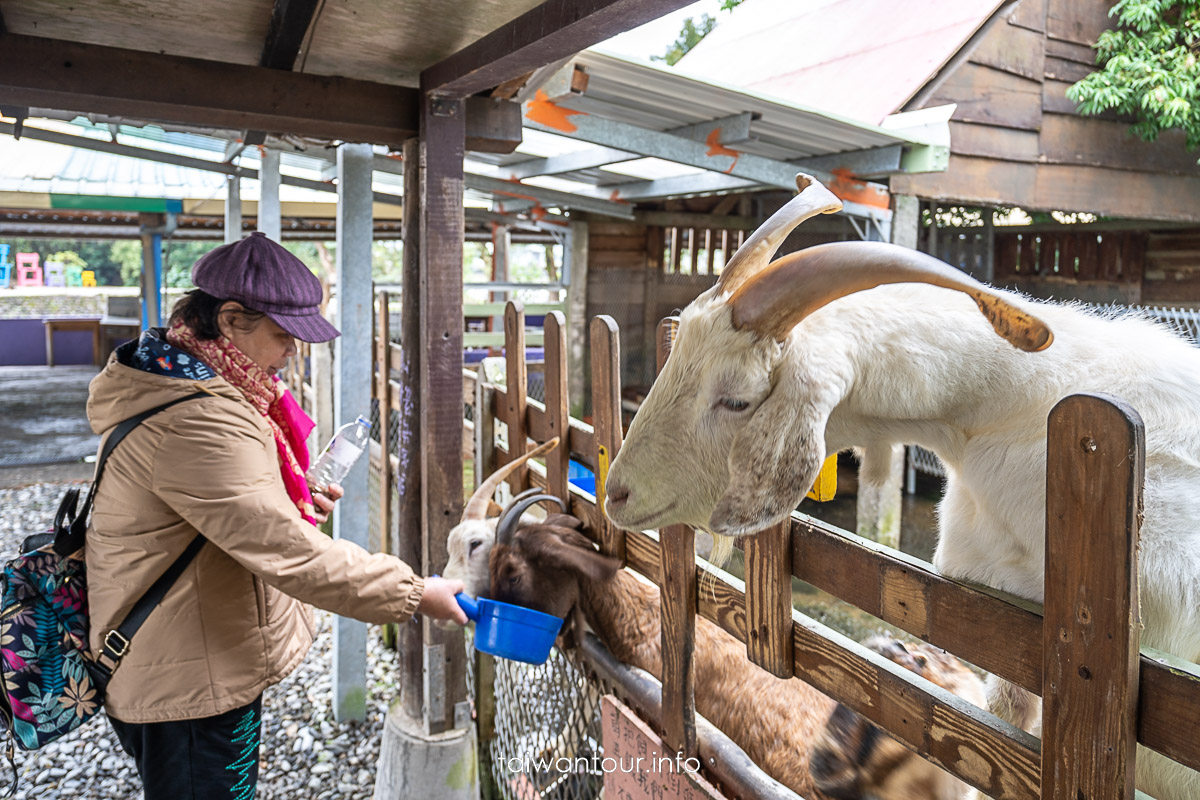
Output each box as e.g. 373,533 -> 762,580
86,354 -> 425,722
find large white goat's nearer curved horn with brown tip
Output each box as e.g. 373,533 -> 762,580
728,242 -> 1054,353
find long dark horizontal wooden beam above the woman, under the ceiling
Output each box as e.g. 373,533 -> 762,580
0,34 -> 418,148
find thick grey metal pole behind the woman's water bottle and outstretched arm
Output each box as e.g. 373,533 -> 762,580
331,144 -> 372,722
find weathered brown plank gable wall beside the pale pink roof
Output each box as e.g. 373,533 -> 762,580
892,0 -> 1200,222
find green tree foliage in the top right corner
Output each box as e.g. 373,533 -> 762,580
1067,0 -> 1200,150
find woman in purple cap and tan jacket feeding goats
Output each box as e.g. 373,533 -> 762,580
88,234 -> 466,800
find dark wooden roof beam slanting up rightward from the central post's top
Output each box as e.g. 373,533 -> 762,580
421,0 -> 690,97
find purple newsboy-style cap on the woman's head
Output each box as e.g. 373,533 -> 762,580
192,230 -> 341,342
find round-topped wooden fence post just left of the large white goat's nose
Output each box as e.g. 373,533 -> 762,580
592,314 -> 625,561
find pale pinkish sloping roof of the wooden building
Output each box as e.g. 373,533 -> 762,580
676,0 -> 1001,122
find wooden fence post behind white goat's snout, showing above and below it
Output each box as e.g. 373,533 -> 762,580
655,317 -> 697,758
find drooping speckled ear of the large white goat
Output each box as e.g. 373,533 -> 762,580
709,360 -> 836,536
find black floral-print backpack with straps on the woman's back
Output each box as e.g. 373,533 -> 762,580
0,392 -> 205,786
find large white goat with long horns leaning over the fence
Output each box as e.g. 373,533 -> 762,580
606,175 -> 1200,800
